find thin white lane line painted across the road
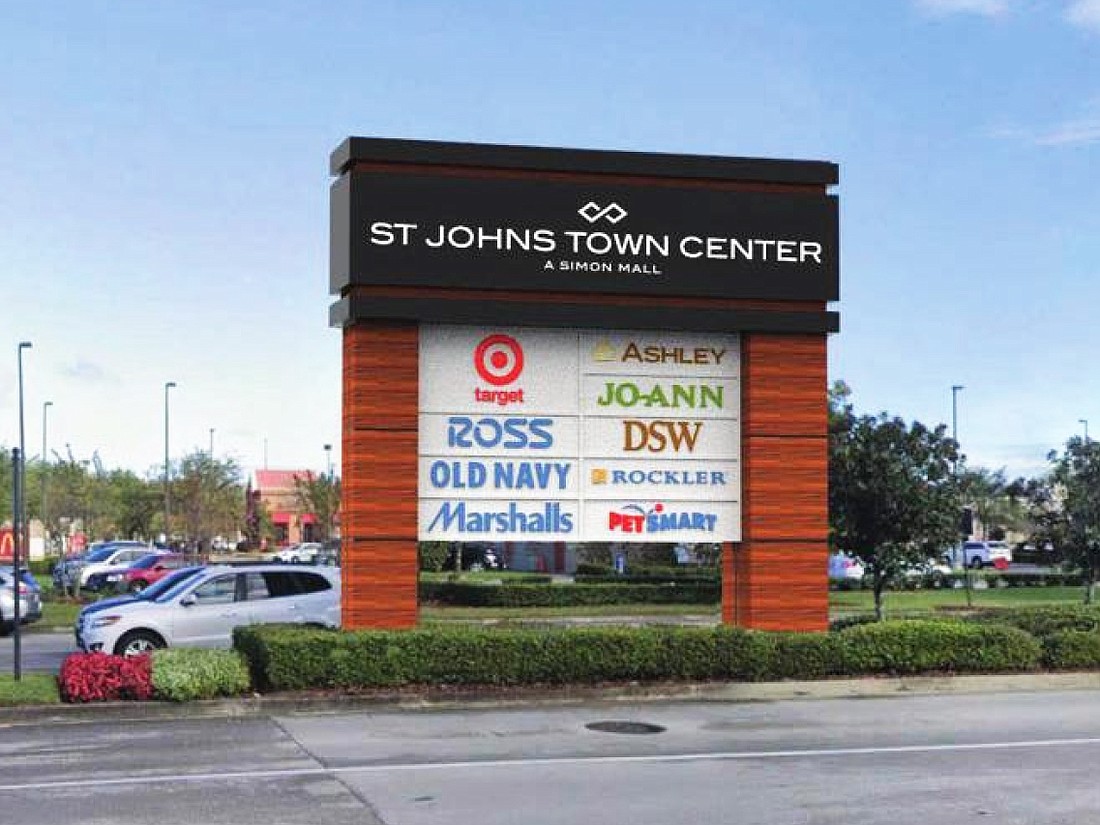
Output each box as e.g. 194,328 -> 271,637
0,737 -> 1100,793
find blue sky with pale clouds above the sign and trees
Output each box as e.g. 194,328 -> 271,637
0,0 -> 1100,474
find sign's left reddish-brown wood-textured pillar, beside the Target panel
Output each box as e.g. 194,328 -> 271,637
341,321 -> 419,629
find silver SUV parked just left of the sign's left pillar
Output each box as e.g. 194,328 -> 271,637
75,563 -> 340,656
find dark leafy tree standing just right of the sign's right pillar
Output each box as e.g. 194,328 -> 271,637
829,392 -> 959,619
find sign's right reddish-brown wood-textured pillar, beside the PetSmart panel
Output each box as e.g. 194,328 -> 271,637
722,332 -> 828,630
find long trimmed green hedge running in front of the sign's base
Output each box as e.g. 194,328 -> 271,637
233,620 -> 1043,691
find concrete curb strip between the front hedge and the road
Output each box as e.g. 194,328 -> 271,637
0,672 -> 1100,728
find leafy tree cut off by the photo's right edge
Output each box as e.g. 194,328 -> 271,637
1033,436 -> 1100,604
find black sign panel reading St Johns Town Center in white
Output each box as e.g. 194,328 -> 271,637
330,167 -> 839,301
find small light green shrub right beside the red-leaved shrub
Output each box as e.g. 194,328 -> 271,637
152,648 -> 250,702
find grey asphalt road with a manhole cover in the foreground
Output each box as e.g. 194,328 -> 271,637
0,691 -> 1100,825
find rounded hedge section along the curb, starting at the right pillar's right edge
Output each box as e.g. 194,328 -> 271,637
836,619 -> 1043,675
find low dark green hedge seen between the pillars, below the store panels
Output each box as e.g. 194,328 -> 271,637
419,582 -> 722,607
